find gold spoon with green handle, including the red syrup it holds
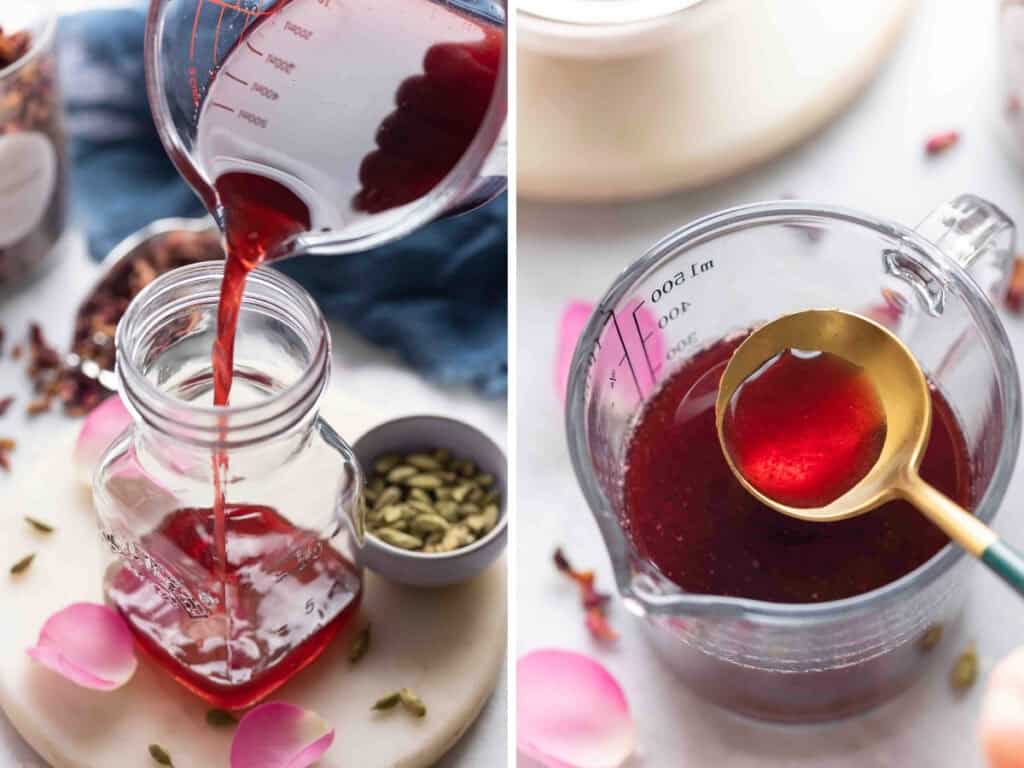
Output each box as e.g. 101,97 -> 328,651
715,309 -> 1024,595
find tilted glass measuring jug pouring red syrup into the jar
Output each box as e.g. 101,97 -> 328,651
145,0 -> 506,257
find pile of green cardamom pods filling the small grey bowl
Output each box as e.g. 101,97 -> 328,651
365,449 -> 501,554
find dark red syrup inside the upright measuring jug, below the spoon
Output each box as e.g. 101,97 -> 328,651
624,338 -> 973,603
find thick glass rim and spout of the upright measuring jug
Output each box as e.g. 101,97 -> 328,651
565,200 -> 1021,626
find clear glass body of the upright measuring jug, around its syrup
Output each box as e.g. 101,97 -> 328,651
566,196 -> 1021,722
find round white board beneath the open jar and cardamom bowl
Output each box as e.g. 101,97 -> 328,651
0,392 -> 506,768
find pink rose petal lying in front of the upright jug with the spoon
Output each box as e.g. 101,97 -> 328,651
516,650 -> 636,768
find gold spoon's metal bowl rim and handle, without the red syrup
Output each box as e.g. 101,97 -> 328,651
715,309 -> 1024,595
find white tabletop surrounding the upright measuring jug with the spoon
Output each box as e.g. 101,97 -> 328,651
516,0 -> 1024,768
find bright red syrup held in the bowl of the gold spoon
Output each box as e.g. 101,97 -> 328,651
722,349 -> 886,508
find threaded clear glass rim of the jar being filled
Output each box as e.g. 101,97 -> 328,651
116,261 -> 331,447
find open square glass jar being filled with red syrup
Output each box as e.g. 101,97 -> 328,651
93,262 -> 362,709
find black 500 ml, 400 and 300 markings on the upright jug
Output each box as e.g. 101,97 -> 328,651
590,259 -> 715,398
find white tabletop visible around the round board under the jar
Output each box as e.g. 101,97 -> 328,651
0,0 -> 508,768
